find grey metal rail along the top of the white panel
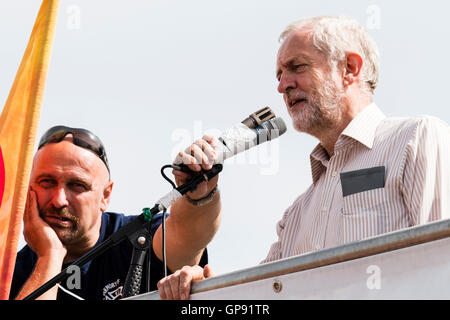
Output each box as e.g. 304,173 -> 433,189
125,220 -> 450,300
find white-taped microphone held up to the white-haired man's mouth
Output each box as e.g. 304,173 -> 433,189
157,107 -> 287,210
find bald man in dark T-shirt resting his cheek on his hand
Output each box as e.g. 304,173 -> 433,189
10,126 -> 220,300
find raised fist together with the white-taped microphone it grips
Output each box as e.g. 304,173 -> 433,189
158,107 -> 286,208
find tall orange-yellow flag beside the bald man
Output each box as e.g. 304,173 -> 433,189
0,0 -> 59,300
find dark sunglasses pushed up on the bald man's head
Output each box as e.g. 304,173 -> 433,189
38,126 -> 109,172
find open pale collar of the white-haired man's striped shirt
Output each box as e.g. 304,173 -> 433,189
310,103 -> 386,184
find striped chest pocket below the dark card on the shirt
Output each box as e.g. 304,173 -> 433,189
339,189 -> 389,244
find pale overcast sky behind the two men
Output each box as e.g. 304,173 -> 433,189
0,0 -> 450,274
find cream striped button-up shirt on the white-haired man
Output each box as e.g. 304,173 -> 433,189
262,103 -> 450,263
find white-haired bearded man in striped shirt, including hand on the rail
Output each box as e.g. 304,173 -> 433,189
158,16 -> 450,299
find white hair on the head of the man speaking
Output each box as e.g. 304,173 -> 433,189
280,16 -> 380,95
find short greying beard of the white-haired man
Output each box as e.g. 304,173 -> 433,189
291,72 -> 344,136
